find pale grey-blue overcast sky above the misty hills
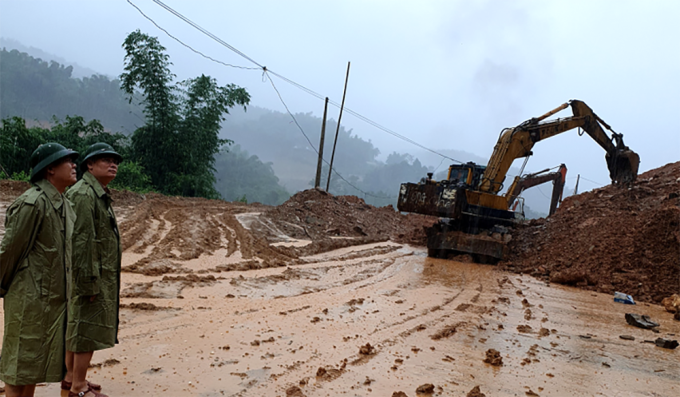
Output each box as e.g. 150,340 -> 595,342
0,0 -> 680,189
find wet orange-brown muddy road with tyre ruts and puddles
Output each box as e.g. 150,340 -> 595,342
0,187 -> 680,397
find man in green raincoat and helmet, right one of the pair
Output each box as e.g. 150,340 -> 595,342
62,143 -> 121,397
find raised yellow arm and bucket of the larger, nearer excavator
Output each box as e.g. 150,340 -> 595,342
480,100 -> 640,194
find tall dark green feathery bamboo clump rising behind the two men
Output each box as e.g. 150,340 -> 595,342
120,30 -> 250,198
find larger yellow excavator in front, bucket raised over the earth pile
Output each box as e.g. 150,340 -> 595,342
397,100 -> 640,263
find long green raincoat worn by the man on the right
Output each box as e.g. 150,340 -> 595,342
66,172 -> 121,353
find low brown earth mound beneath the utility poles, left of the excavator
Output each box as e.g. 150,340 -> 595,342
263,189 -> 437,245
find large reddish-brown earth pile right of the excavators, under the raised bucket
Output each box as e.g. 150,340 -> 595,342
499,162 -> 680,303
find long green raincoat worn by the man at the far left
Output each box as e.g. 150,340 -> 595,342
0,180 -> 75,386
